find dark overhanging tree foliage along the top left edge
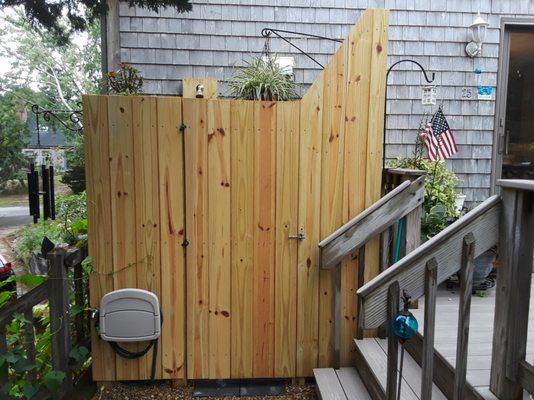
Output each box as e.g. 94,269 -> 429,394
0,0 -> 191,43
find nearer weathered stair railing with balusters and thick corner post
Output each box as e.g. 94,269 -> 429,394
358,181 -> 534,400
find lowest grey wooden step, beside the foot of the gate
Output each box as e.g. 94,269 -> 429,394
313,368 -> 371,400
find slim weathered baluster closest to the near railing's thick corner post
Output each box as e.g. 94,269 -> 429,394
453,233 -> 475,400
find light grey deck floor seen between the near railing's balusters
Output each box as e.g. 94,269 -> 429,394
412,280 -> 534,399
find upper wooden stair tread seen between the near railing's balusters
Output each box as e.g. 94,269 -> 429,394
354,338 -> 447,400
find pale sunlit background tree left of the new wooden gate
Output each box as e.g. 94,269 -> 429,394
0,10 -> 101,192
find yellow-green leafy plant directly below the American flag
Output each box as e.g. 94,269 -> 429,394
389,157 -> 460,240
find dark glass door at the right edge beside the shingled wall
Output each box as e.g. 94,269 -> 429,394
499,27 -> 534,179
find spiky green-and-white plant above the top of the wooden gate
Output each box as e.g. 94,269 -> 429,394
229,56 -> 297,101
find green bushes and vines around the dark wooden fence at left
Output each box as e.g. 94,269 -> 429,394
0,193 -> 91,399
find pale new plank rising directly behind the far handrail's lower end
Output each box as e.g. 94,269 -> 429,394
318,44 -> 355,367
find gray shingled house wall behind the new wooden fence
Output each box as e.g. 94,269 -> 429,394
120,0 -> 534,202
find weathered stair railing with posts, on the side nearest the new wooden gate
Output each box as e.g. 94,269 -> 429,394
319,171 -> 425,365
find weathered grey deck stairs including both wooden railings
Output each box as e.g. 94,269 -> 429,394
314,178 -> 534,400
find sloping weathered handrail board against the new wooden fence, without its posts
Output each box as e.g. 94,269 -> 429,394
319,176 -> 425,269
